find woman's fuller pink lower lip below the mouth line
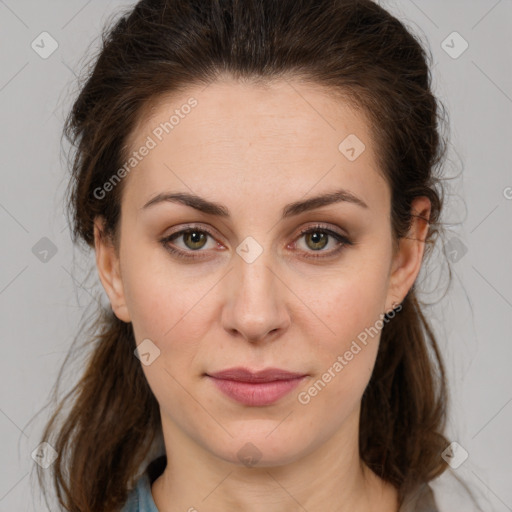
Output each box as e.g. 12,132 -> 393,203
210,377 -> 305,407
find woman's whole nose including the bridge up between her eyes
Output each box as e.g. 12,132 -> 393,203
223,242 -> 288,340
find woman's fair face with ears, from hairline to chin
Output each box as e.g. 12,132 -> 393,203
96,79 -> 428,465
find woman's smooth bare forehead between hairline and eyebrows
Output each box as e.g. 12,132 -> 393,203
123,79 -> 388,216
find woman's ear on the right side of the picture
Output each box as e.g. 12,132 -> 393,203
386,196 -> 431,311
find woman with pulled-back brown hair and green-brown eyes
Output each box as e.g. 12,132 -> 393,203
34,0 -> 482,512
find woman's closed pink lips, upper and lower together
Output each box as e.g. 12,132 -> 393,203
207,368 -> 307,407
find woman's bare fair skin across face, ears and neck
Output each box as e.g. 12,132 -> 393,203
95,78 -> 430,512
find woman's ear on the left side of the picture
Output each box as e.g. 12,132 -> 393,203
94,217 -> 131,323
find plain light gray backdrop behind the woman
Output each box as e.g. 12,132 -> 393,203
0,0 -> 512,512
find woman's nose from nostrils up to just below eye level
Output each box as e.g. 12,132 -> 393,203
222,254 -> 291,343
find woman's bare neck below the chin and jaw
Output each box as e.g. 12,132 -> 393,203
152,408 -> 398,512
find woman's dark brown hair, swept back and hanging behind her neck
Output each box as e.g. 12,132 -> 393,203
32,0 -> 478,512
